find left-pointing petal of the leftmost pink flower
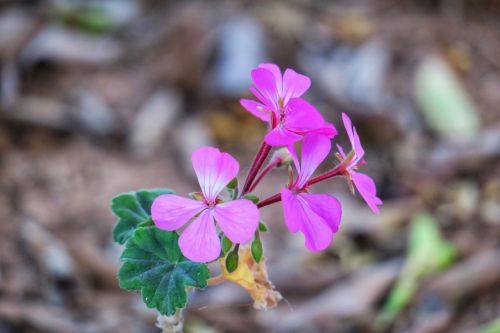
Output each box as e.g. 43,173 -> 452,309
151,194 -> 207,231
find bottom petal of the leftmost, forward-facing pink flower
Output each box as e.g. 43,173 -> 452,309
179,209 -> 221,262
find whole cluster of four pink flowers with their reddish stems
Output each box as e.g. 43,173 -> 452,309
151,64 -> 382,262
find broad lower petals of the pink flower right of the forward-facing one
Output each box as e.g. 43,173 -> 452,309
281,189 -> 342,251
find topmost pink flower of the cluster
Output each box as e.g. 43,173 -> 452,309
240,64 -> 337,146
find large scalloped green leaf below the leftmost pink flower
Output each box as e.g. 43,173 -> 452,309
118,227 -> 209,316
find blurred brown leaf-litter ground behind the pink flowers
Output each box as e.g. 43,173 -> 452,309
0,0 -> 500,333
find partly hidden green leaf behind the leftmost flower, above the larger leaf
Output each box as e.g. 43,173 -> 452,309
111,189 -> 175,244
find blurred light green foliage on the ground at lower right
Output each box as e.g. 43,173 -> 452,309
376,214 -> 456,330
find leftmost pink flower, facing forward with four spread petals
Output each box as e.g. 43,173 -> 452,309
151,147 -> 260,262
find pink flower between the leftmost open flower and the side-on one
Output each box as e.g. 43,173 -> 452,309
281,134 -> 342,251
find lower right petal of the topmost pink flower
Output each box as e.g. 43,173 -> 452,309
284,98 -> 337,138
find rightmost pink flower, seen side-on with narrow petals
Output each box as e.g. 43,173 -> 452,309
337,113 -> 382,214
